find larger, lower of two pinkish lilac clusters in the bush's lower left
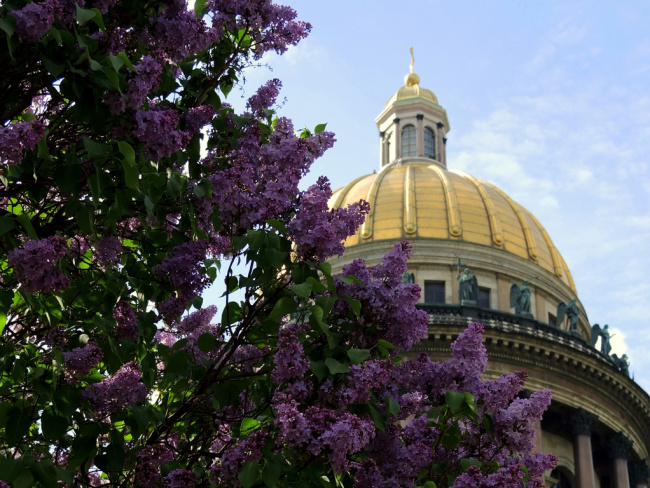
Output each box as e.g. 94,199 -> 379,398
81,361 -> 147,415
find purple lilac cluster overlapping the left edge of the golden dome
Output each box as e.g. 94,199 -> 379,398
289,176 -> 370,261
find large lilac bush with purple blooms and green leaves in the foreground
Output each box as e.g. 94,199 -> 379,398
0,0 -> 553,488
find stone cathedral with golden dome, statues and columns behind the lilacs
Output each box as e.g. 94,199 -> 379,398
330,64 -> 650,488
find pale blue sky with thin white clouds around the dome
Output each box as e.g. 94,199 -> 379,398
204,0 -> 650,390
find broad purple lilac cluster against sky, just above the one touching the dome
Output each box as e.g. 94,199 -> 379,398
205,119 -> 334,232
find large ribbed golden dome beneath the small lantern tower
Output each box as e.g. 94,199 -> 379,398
330,162 -> 576,292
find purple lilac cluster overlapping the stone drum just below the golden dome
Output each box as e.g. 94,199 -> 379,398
334,241 -> 429,351
